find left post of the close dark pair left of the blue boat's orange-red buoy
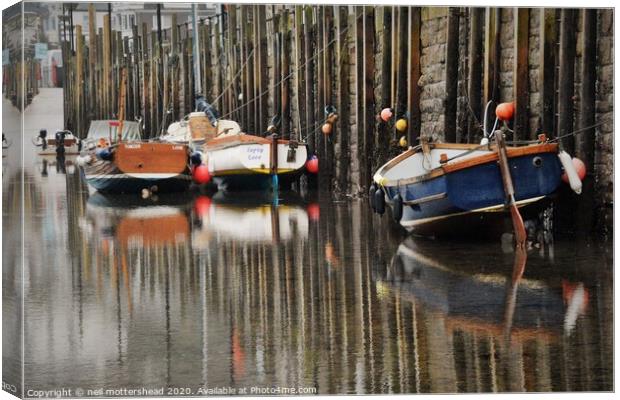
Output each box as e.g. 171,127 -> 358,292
467,7 -> 484,143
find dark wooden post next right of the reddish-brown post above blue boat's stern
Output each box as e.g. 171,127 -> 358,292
538,8 -> 558,137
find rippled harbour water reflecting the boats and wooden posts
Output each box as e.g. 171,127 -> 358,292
17,165 -> 613,394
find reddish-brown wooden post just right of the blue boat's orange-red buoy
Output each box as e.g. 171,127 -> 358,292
513,7 -> 536,140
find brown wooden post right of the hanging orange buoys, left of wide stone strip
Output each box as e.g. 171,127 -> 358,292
406,7 -> 422,145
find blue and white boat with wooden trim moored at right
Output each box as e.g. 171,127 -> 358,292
371,138 -> 563,236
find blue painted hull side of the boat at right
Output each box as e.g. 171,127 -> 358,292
385,153 -> 562,234
